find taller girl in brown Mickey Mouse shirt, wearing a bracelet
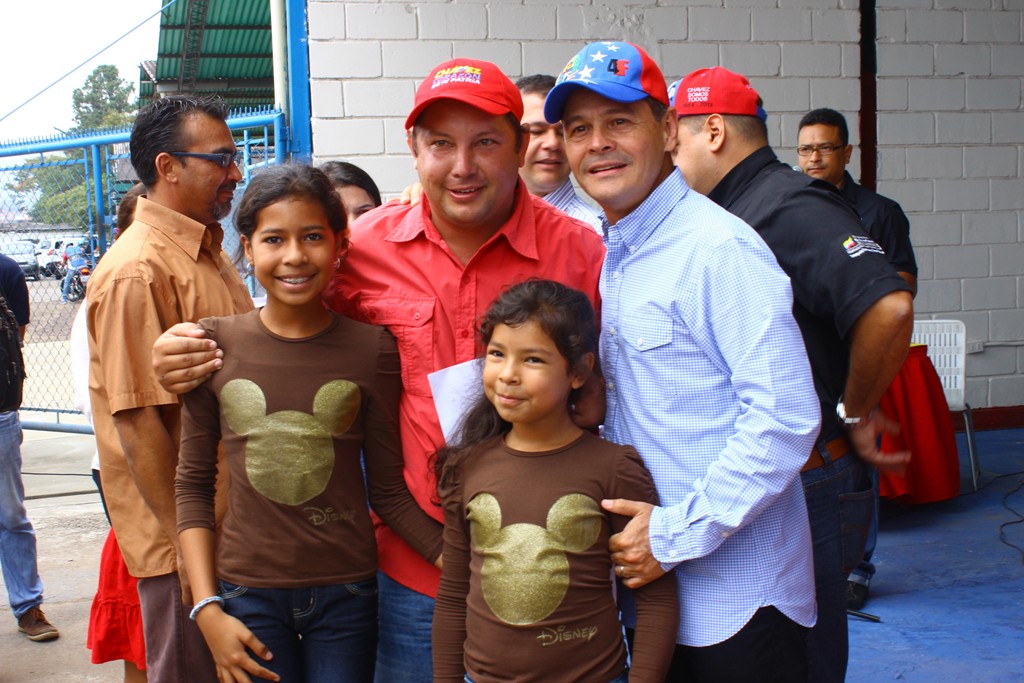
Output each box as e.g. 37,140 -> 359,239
176,166 -> 440,683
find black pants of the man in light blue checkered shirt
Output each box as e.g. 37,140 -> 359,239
665,607 -> 809,683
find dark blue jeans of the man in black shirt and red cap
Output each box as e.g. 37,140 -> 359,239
801,449 -> 873,683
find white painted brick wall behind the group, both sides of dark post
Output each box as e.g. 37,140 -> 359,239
308,0 -> 1024,407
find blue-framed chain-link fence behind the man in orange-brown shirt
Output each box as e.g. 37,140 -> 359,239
0,110 -> 284,431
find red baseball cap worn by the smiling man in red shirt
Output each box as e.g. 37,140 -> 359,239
406,57 -> 522,130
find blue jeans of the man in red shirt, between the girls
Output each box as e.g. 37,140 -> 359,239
374,571 -> 434,683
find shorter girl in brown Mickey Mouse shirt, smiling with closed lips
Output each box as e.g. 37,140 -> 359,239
433,280 -> 678,683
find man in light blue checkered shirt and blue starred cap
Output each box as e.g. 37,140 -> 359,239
545,42 -> 820,681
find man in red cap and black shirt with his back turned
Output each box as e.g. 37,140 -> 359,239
675,67 -> 913,683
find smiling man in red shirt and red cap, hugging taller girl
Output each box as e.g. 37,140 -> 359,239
154,58 -> 604,683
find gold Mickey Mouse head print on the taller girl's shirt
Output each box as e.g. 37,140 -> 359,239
220,379 -> 360,505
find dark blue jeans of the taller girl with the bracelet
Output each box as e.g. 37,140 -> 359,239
220,579 -> 377,683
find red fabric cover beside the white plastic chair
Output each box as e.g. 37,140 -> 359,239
879,344 -> 959,504
